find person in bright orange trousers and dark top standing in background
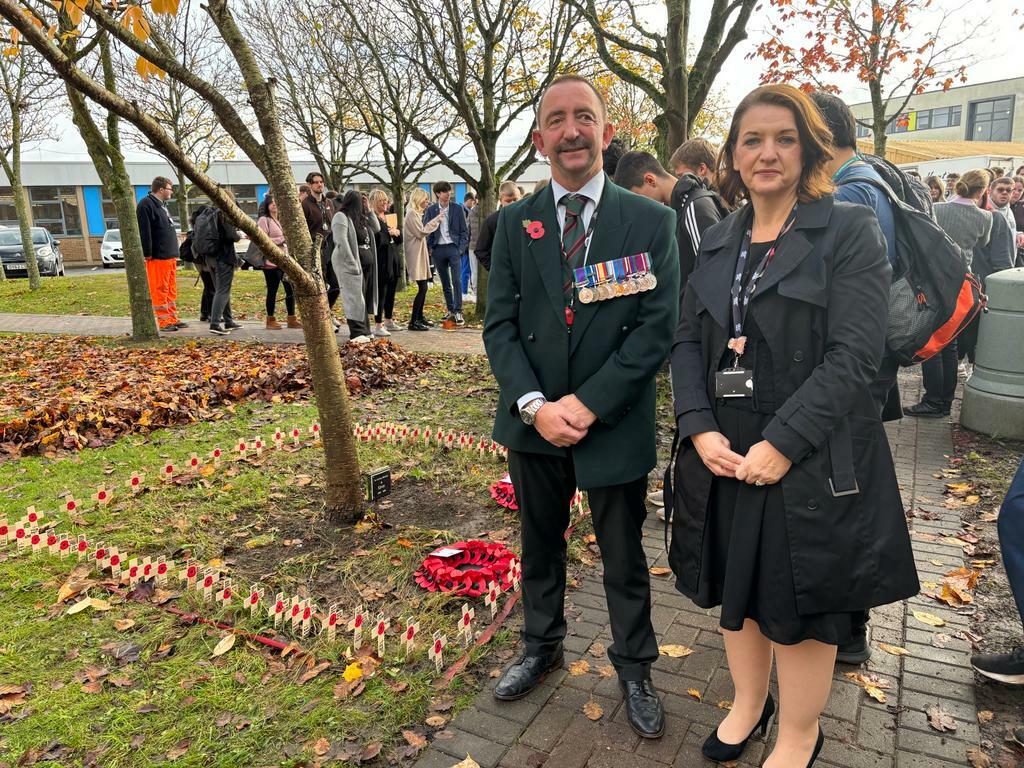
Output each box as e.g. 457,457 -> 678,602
135,176 -> 188,331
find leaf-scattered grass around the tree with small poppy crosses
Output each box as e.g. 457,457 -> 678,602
0,344 -> 524,768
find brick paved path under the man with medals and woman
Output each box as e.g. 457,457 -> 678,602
417,375 -> 980,768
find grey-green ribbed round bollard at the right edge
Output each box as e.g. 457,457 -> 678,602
961,267 -> 1024,440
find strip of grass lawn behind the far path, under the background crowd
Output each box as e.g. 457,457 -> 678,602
0,267 -> 472,323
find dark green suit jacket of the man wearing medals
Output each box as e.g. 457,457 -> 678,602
483,177 -> 679,489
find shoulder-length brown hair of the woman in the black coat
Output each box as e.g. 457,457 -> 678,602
716,84 -> 833,207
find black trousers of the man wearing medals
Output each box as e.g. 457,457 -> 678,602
509,451 -> 658,680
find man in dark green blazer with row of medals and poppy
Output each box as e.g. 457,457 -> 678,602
483,76 -> 679,738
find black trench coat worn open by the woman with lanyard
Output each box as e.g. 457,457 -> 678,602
666,196 -> 919,615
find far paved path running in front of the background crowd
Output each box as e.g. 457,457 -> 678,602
0,312 -> 483,354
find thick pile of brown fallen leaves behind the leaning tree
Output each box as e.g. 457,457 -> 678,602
0,336 -> 430,461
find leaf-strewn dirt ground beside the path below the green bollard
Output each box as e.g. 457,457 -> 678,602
951,427 -> 1024,768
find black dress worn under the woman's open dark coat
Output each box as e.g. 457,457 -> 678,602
695,243 -> 862,645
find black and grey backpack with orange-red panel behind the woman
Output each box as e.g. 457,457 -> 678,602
850,178 -> 984,366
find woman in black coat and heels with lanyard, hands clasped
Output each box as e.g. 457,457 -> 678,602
667,85 -> 918,768
